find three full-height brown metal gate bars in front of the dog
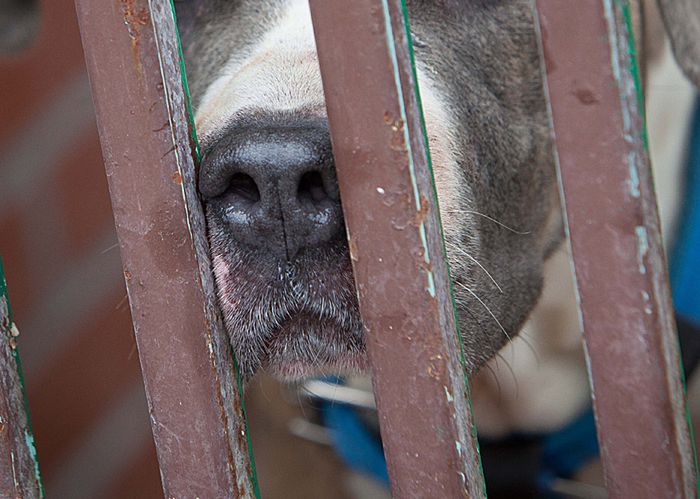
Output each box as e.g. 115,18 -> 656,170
0,0 -> 697,498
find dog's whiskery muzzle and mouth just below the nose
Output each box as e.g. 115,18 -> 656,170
208,216 -> 366,379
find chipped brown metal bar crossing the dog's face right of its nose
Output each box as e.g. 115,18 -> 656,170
310,0 -> 485,497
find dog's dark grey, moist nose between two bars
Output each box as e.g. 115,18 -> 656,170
199,123 -> 343,260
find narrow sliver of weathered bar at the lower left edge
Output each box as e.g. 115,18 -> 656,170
0,262 -> 44,498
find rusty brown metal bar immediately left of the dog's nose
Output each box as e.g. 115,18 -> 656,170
76,0 -> 257,497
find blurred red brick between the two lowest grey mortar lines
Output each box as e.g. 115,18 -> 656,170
27,288 -> 141,479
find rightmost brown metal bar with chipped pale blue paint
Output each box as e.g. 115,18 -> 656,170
537,0 -> 697,499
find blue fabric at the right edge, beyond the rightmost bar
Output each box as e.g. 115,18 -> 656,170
670,99 -> 700,327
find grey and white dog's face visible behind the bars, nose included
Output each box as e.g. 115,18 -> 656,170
176,0 -> 562,377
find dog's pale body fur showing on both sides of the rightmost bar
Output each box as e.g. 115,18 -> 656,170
471,0 -> 698,437
